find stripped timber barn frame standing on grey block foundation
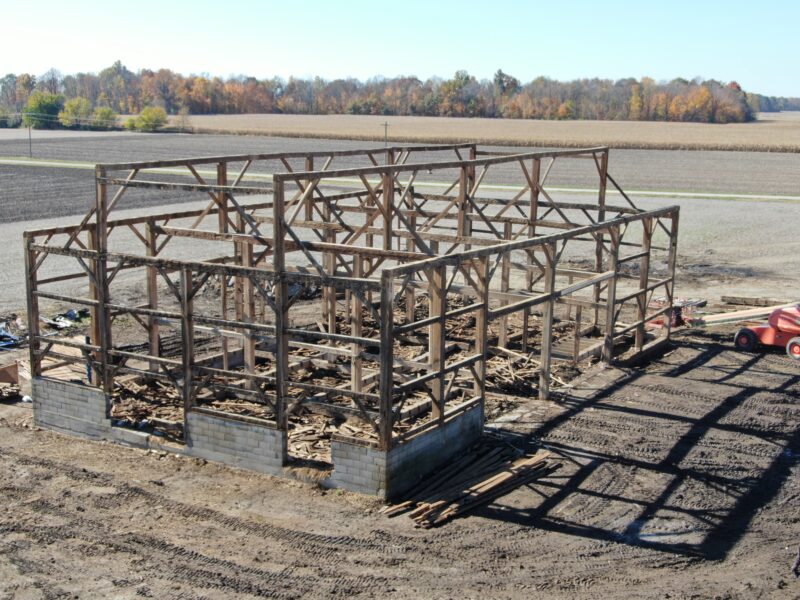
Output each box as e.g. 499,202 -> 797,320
25,144 -> 679,496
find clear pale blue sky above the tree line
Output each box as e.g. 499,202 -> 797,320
0,0 -> 800,96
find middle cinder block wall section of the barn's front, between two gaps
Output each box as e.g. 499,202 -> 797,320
186,409 -> 286,475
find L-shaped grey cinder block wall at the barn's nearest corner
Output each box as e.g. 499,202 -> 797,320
330,405 -> 483,498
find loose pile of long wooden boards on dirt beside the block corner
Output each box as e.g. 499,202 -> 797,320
382,448 -> 561,528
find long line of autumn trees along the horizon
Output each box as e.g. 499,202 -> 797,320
0,61 -> 800,128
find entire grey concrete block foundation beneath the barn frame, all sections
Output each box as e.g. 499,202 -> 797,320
32,377 -> 483,498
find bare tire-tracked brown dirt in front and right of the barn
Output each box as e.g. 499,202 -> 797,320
0,331 -> 800,599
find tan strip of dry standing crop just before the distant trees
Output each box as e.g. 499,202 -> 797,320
173,112 -> 800,152
